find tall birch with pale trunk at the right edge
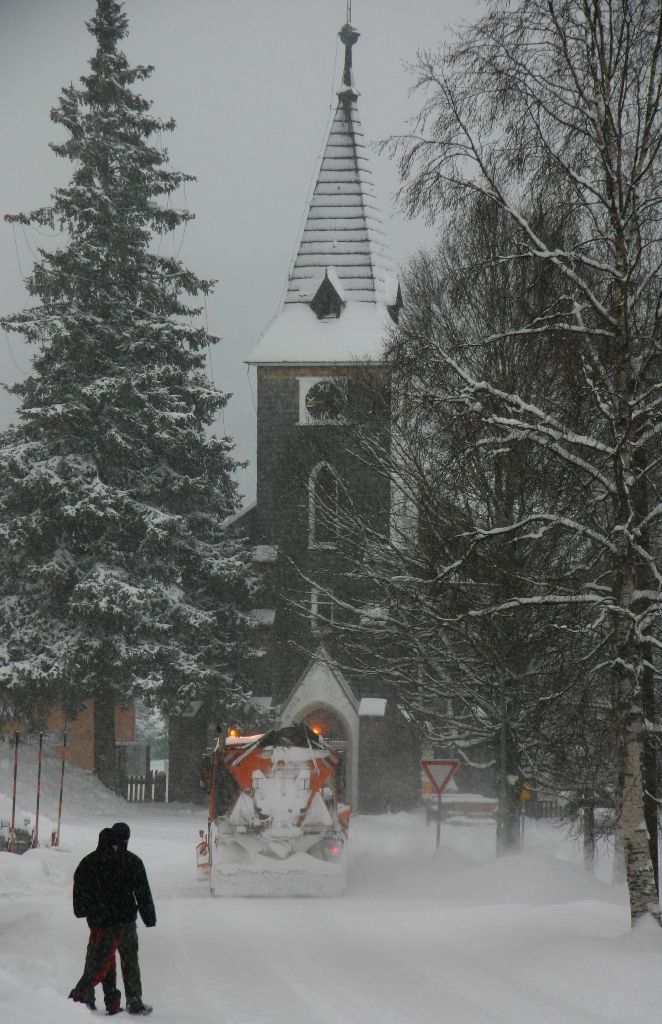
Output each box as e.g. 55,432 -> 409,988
394,0 -> 662,923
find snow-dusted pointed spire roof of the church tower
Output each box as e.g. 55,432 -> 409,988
249,25 -> 401,366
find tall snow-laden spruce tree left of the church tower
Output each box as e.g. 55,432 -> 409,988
0,0 -> 250,784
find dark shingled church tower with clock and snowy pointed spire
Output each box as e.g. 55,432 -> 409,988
245,24 -> 418,806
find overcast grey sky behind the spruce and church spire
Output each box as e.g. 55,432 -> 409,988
0,0 -> 478,500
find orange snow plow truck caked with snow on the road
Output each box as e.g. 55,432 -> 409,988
197,725 -> 350,896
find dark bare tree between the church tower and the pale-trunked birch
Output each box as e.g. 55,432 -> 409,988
319,199 -> 602,854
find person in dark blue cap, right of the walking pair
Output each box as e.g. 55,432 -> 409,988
111,821 -> 157,1016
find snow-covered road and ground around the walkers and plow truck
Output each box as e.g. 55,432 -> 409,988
0,749 -> 662,1024
